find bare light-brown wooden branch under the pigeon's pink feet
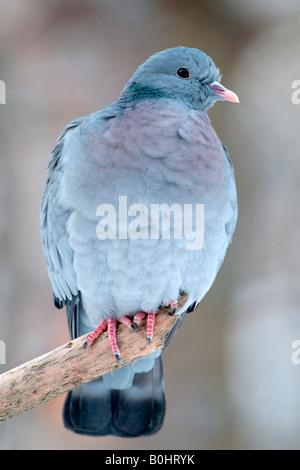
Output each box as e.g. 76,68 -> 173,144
0,295 -> 187,421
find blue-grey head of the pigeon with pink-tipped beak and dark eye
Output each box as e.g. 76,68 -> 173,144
121,47 -> 239,112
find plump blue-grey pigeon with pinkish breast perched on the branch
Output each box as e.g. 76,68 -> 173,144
40,47 -> 239,437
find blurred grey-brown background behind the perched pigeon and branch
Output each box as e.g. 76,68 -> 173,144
0,0 -> 300,450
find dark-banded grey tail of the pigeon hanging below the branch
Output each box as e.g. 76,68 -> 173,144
63,296 -> 165,437
